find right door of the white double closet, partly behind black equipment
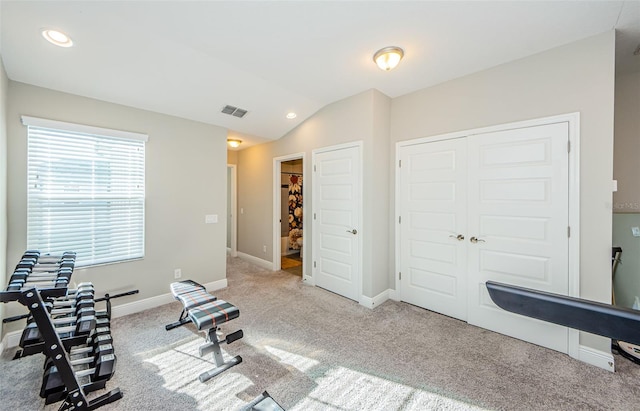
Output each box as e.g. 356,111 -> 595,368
466,123 -> 569,353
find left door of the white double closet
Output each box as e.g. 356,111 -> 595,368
399,139 -> 467,320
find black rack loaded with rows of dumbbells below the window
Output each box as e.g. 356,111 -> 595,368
0,250 -> 138,410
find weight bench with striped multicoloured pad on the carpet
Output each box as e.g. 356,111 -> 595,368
165,280 -> 243,382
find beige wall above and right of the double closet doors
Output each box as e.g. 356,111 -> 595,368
390,31 -> 615,351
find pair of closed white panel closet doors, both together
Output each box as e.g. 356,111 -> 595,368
398,122 -> 569,353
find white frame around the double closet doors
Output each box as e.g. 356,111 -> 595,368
394,112 -> 580,363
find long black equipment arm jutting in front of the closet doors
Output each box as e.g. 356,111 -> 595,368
486,281 -> 640,345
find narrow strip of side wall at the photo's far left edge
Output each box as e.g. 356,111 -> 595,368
0,55 -> 9,340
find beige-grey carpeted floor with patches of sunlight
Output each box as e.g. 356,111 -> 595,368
0,259 -> 640,411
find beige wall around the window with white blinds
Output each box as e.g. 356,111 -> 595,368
6,81 -> 227,336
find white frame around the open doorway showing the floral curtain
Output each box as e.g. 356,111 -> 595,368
272,152 -> 310,282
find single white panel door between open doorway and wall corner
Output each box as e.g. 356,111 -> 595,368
312,145 -> 362,301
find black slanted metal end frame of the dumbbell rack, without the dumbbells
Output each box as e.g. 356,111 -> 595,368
0,253 -> 122,410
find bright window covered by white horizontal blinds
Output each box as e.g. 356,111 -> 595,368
22,116 -> 147,266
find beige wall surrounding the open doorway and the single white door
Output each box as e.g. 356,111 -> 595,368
238,90 -> 390,297
